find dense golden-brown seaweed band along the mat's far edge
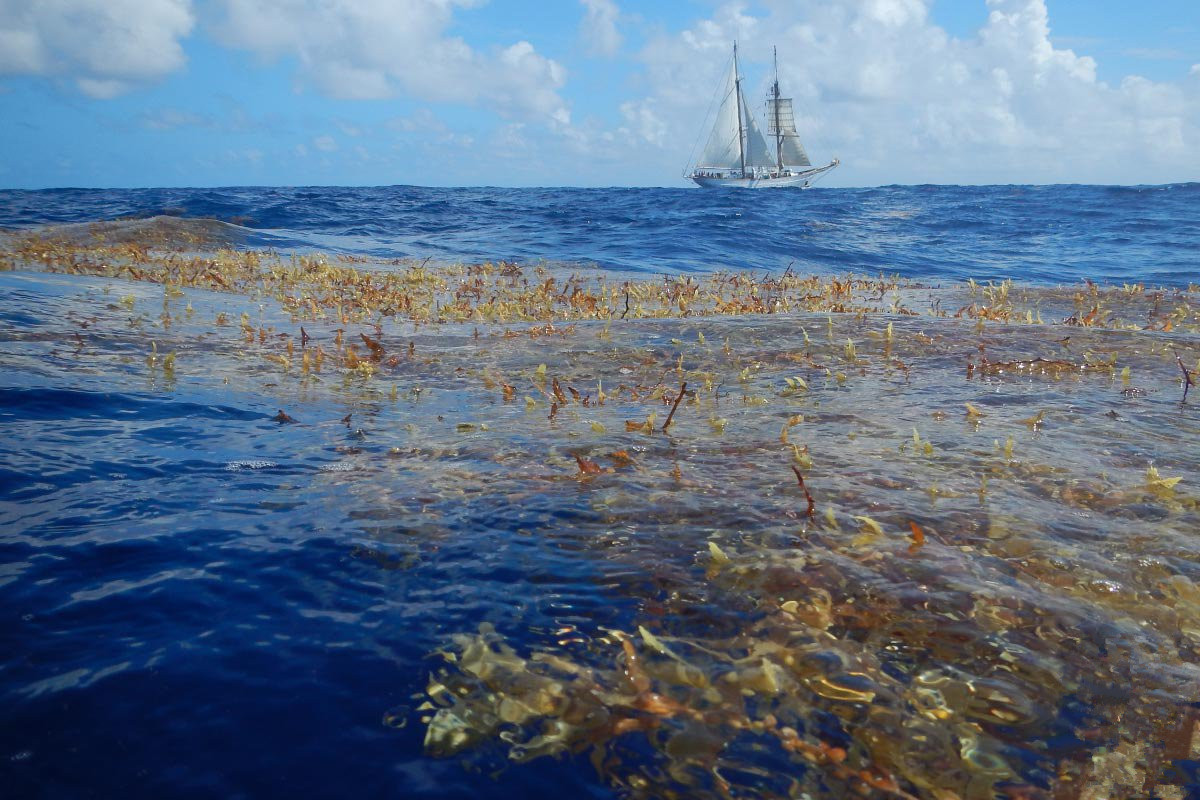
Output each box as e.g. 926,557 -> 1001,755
7,225 -> 1200,335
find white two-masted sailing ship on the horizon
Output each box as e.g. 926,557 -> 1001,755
686,42 -> 841,188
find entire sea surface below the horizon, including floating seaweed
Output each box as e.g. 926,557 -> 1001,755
0,184 -> 1200,800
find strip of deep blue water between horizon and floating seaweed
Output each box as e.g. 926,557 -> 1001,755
0,184 -> 1200,285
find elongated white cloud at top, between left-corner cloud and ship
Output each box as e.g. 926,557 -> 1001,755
214,0 -> 570,125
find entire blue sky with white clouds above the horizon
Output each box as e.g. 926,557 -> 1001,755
0,0 -> 1200,188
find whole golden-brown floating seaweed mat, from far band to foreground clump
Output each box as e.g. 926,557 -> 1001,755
6,220 -> 1200,800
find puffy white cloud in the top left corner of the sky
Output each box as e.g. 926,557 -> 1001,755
0,0 -> 194,98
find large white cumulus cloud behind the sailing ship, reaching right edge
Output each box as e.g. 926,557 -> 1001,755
622,0 -> 1200,184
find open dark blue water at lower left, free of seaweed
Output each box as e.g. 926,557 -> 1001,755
0,272 -> 628,799
